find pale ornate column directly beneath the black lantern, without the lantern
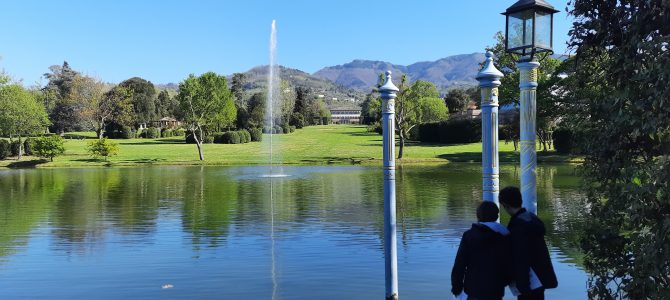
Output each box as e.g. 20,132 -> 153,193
517,58 -> 540,214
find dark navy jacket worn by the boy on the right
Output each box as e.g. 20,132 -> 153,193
507,208 -> 558,294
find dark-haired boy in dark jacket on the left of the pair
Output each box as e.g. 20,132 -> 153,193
451,202 -> 511,300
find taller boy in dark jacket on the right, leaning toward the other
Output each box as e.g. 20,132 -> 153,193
499,186 -> 558,300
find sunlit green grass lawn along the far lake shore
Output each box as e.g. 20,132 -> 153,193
0,125 -> 584,167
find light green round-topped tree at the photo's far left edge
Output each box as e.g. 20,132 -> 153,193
0,84 -> 49,160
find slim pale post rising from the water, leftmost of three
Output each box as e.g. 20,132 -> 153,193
379,71 -> 398,300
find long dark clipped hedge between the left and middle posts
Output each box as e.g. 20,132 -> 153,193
419,119 -> 482,144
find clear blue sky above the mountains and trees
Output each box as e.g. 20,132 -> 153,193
0,0 -> 571,85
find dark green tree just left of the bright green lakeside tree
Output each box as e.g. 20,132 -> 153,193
119,77 -> 161,124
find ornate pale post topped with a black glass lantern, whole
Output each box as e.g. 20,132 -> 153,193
503,0 -> 558,213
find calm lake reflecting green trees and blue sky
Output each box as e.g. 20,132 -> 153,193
0,164 -> 587,300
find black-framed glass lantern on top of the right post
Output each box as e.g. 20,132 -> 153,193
502,0 -> 558,58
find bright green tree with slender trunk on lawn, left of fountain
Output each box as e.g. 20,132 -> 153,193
177,72 -> 237,160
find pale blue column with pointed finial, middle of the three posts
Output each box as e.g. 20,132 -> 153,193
477,51 -> 503,205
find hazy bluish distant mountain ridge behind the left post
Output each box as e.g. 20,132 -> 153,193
314,53 -> 485,92
